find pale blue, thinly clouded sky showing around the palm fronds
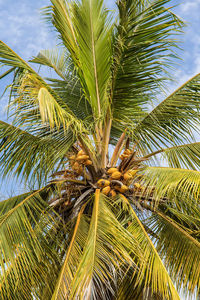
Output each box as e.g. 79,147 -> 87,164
0,0 -> 200,199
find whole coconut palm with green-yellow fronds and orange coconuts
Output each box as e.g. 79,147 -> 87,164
0,0 -> 200,300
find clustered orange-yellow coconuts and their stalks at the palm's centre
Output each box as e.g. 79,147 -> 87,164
50,146 -> 144,214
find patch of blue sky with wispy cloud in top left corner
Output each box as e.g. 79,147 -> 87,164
0,0 -> 56,59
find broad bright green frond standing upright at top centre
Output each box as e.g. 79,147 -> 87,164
44,0 -> 112,123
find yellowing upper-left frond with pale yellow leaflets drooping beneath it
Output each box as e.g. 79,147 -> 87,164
0,42 -> 97,168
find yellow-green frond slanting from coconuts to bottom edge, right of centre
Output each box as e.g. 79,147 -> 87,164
121,196 -> 180,299
